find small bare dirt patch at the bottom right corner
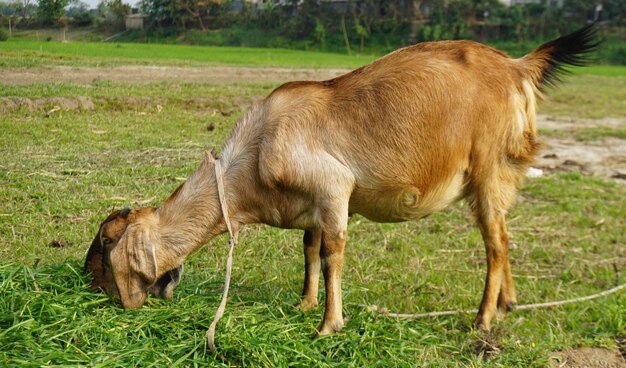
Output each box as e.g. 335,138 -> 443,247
550,347 -> 626,368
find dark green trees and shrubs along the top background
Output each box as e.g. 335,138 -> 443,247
0,0 -> 626,64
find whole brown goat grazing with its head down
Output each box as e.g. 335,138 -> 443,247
87,26 -> 595,334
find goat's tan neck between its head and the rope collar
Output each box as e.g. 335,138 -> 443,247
156,155 -> 226,271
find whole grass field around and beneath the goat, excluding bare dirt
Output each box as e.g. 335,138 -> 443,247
0,42 -> 626,367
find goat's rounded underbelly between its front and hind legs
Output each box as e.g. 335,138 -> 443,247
350,174 -> 463,222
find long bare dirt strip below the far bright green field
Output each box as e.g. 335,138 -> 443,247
0,66 -> 348,84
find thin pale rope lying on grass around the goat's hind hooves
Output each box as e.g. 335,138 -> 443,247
365,284 -> 626,319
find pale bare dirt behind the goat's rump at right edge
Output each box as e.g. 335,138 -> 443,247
536,116 -> 626,184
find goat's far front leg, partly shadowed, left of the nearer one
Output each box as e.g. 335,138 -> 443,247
297,230 -> 322,311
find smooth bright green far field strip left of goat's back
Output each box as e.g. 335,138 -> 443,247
0,39 -> 374,68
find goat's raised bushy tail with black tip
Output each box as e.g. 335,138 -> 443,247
522,23 -> 600,90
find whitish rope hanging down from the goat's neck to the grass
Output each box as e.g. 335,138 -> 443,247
207,160 -> 237,353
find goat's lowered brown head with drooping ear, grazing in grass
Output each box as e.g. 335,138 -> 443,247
85,208 -> 183,309
